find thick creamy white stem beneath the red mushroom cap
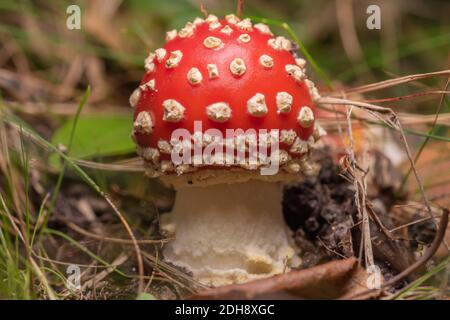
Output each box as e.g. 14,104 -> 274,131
162,180 -> 295,286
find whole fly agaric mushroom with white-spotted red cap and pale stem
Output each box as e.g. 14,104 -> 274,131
130,15 -> 324,285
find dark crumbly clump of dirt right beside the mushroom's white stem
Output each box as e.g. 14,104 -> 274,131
283,156 -> 356,268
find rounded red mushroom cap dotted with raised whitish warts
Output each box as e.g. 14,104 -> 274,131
130,15 -> 321,180
